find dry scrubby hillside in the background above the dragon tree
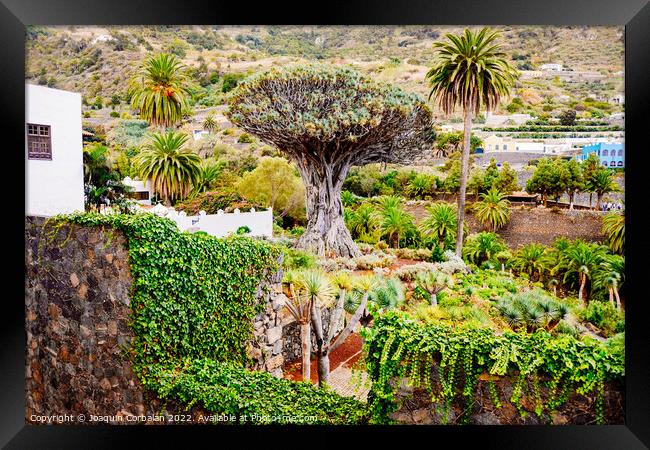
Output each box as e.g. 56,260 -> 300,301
26,26 -> 624,119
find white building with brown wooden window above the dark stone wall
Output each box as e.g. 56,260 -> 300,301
25,84 -> 84,216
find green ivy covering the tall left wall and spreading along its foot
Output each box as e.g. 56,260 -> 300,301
44,213 -> 363,422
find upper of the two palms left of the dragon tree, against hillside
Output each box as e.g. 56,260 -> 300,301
129,53 -> 191,131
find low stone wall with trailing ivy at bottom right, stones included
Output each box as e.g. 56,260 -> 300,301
364,312 -> 625,425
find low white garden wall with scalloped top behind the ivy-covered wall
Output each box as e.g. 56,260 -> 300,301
152,203 -> 273,238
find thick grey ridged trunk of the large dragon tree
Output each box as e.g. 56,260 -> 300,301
297,163 -> 361,258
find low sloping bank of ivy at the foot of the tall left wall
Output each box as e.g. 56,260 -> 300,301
146,358 -> 366,425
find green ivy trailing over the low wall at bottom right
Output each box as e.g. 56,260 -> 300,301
363,311 -> 625,423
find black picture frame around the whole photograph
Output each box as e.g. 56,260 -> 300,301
0,0 -> 650,449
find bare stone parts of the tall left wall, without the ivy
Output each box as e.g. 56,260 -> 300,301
25,217 -> 284,421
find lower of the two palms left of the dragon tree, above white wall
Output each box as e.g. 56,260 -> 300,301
135,131 -> 201,206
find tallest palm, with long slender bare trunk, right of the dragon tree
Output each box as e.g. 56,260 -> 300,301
426,28 -> 517,256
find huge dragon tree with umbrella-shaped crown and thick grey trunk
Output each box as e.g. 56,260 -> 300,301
226,65 -> 433,257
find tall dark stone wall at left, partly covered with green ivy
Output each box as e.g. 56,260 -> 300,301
25,214 -> 362,423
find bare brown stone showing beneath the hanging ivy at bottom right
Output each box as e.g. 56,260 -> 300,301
390,366 -> 625,425
